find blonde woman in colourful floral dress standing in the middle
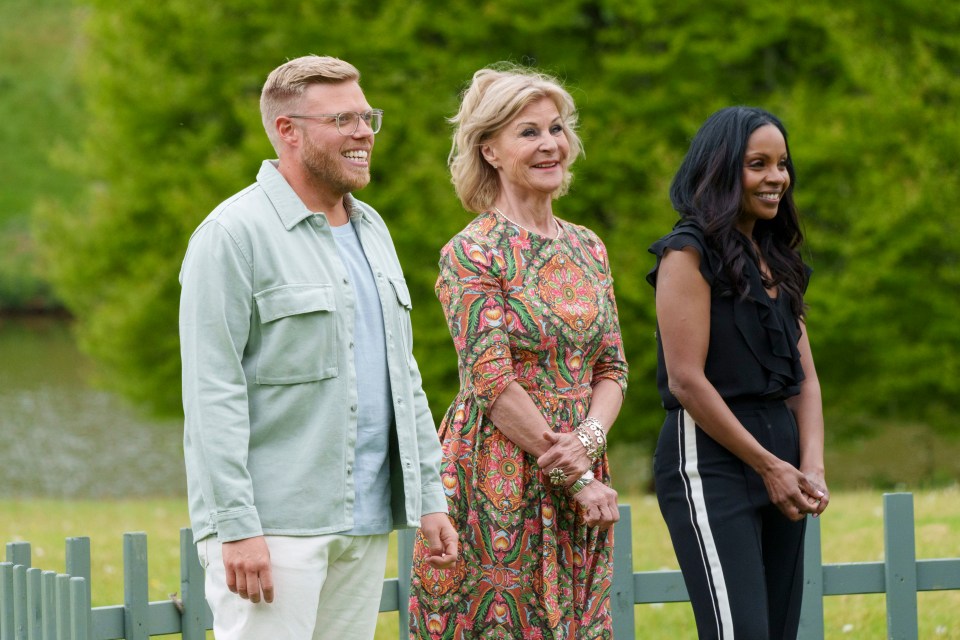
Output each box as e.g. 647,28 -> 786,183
410,67 -> 627,638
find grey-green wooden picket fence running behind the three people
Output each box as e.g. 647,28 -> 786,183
0,493 -> 960,640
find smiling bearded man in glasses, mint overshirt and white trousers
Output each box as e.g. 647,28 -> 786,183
180,56 -> 457,640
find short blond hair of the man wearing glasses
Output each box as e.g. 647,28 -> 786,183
260,55 -> 360,154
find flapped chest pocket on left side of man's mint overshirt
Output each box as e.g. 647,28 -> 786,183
254,284 -> 338,384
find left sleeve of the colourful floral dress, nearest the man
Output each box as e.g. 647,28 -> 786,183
436,234 -> 516,414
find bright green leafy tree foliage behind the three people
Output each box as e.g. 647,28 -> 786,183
36,0 -> 960,442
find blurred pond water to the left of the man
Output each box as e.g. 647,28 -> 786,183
0,318 -> 186,498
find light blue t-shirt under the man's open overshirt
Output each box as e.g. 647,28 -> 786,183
330,223 -> 393,536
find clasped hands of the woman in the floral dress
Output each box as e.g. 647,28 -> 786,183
537,432 -> 620,529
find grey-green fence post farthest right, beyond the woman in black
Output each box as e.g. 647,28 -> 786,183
883,493 -> 919,640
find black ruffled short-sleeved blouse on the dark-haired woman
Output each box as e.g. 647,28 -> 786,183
647,220 -> 809,411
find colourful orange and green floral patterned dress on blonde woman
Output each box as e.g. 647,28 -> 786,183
410,212 -> 627,640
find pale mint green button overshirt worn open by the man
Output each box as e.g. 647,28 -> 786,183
180,161 -> 447,542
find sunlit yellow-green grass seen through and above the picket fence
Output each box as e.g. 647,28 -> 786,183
0,487 -> 960,640
